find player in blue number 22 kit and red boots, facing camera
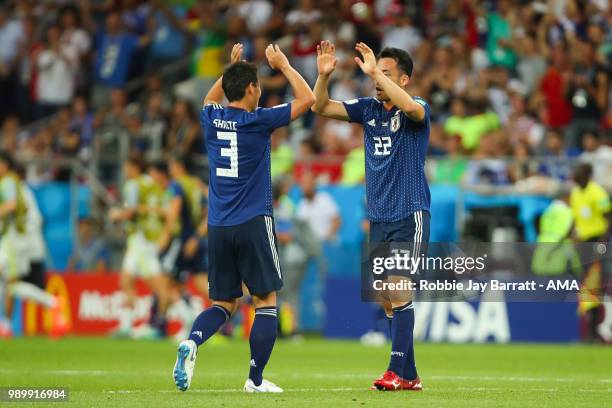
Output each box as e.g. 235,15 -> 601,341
312,41 -> 430,390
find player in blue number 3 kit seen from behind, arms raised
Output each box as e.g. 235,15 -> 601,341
174,44 -> 314,392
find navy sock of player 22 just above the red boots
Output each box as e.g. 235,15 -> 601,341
388,302 -> 414,378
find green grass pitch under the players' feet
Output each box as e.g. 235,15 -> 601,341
0,338 -> 612,408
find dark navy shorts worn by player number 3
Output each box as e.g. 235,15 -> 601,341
208,215 -> 283,300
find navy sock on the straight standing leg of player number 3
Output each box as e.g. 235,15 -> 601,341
249,306 -> 278,386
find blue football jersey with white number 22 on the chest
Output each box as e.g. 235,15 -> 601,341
344,97 -> 430,222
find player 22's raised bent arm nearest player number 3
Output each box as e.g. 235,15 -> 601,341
311,41 -> 349,121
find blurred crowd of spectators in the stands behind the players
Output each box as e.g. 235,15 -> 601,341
0,0 -> 612,192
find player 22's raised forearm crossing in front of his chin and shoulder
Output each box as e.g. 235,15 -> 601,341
355,43 -> 425,122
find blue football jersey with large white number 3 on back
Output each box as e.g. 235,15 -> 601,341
200,104 -> 291,227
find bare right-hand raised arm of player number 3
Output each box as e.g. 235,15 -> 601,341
266,44 -> 315,120
